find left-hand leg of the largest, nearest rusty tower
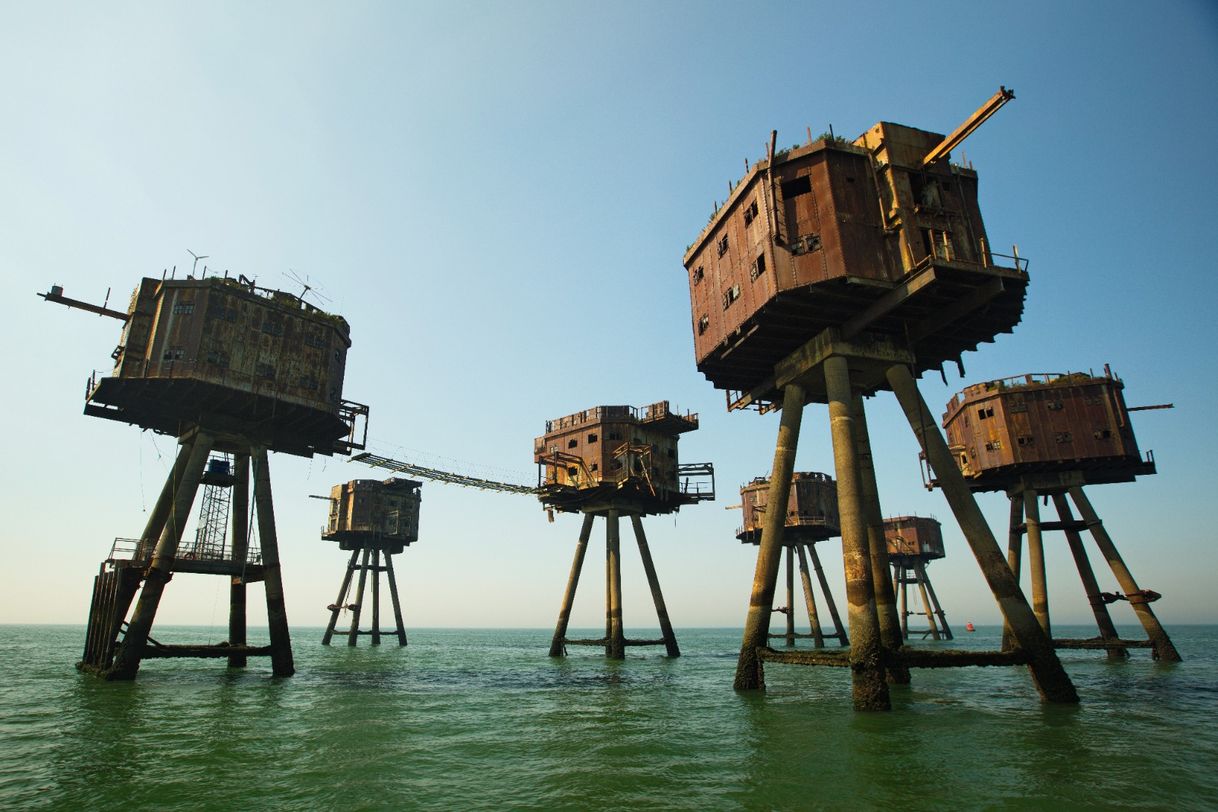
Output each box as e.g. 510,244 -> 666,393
733,383 -> 806,690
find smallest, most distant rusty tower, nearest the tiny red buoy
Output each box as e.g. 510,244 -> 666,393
884,516 -> 952,640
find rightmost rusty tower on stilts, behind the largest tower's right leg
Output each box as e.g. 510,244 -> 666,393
924,365 -> 1180,662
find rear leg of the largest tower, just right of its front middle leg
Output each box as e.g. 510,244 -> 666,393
851,394 -> 910,685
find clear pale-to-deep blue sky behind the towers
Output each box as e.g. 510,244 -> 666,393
0,0 -> 1218,634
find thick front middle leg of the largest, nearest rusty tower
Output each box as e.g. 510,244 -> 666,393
823,355 -> 892,711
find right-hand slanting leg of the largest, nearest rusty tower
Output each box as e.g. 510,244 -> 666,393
887,365 -> 1078,702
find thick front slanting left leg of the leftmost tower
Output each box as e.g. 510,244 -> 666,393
106,431 -> 213,679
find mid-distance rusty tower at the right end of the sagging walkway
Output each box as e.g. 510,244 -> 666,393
533,401 -> 715,660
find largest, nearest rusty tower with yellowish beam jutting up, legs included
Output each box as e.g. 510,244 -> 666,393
683,88 -> 1078,710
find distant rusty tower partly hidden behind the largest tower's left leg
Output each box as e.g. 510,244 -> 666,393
736,471 -> 850,649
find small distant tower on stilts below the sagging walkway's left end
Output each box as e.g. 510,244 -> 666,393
322,478 -> 423,645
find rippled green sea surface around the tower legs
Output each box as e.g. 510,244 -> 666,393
0,626 -> 1218,810
